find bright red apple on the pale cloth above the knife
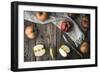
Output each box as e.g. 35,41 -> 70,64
60,21 -> 72,32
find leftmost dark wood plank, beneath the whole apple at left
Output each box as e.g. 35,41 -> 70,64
24,21 -> 35,62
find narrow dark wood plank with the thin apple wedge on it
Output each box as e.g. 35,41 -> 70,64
48,23 -> 57,60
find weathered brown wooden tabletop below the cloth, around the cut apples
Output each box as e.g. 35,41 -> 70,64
24,17 -> 89,62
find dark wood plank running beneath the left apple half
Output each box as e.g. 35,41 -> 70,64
36,24 -> 49,61
